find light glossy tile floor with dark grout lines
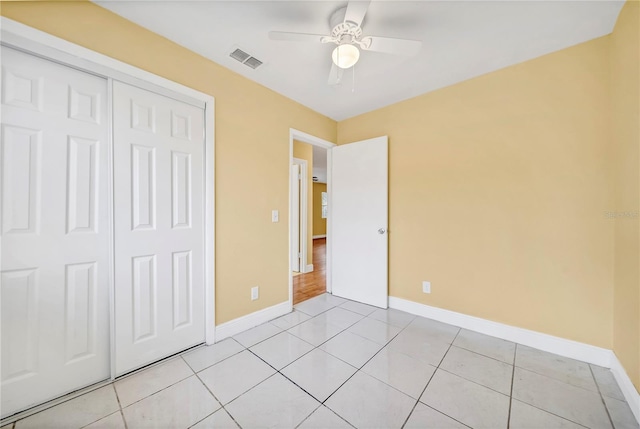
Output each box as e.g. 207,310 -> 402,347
0,294 -> 638,429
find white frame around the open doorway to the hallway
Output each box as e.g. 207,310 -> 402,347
287,128 -> 336,308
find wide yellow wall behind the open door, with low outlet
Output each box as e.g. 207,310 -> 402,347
338,37 -> 613,348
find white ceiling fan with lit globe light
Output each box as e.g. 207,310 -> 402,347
269,0 -> 422,85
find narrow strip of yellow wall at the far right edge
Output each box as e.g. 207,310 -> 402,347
611,1 -> 640,390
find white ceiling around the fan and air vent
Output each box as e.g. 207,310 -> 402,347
96,0 -> 624,120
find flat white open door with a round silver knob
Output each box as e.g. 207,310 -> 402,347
330,136 -> 389,308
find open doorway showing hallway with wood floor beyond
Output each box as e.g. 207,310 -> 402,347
289,129 -> 335,305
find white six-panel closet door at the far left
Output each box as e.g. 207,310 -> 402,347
0,47 -> 110,417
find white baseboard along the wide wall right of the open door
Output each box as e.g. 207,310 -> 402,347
389,296 -> 611,368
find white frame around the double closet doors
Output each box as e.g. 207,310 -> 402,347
0,17 -> 215,372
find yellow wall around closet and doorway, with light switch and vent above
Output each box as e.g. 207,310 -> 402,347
1,2 -> 336,324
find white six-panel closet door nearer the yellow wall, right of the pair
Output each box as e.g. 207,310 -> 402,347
113,82 -> 205,375
